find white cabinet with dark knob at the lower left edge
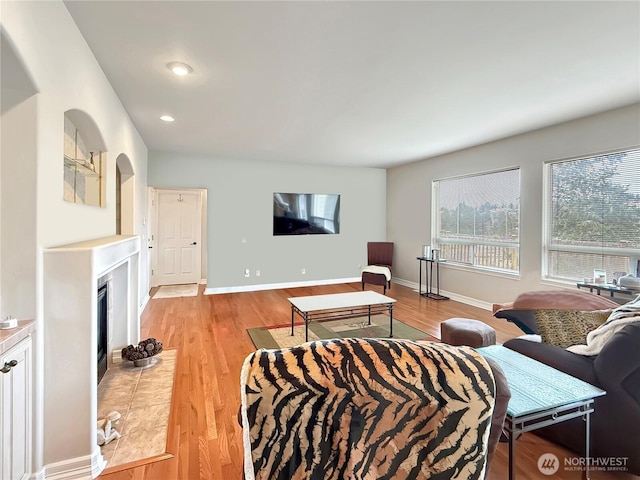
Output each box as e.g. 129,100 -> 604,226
0,336 -> 32,480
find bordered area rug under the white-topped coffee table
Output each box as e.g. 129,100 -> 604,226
247,315 -> 438,348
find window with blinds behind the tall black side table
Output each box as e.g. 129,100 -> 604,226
432,168 -> 520,273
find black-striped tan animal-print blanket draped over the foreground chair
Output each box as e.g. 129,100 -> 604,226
241,339 -> 495,480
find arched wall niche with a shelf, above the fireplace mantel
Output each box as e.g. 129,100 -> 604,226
63,109 -> 107,207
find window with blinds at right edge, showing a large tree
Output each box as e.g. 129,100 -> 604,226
545,149 -> 640,283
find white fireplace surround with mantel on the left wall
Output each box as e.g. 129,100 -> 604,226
43,235 -> 140,478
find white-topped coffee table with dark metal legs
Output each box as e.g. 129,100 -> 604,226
288,290 -> 395,342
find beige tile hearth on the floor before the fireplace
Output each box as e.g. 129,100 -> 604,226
98,349 -> 177,469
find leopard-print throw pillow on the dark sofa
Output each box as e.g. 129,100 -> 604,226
534,310 -> 613,348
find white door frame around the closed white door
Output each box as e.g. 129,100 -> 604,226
147,187 -> 207,288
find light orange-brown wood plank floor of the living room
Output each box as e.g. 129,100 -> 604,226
99,284 -> 638,480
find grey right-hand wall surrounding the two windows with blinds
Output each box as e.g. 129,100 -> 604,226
387,104 -> 640,306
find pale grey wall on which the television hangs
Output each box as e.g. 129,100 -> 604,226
148,152 -> 386,292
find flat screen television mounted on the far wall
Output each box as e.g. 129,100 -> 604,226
273,193 -> 340,235
